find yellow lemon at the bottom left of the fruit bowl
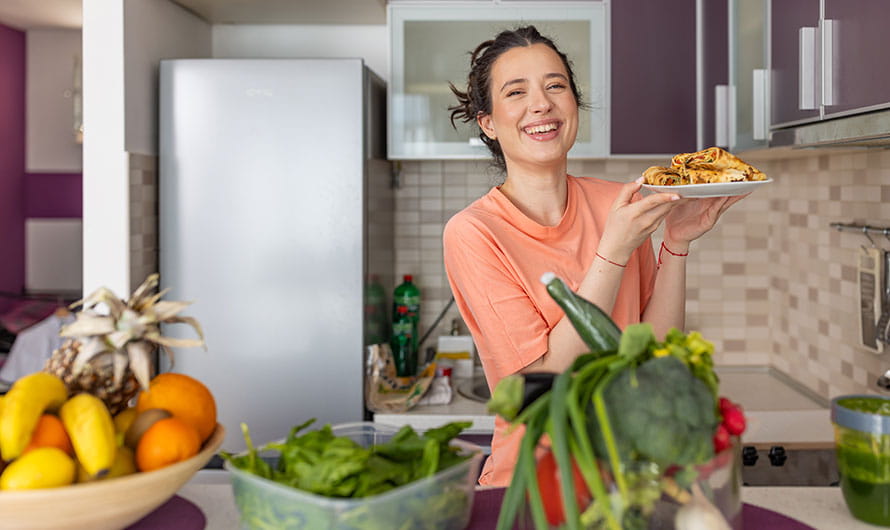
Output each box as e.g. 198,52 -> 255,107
0,447 -> 75,490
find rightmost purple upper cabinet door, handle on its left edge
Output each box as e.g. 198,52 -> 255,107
820,0 -> 890,117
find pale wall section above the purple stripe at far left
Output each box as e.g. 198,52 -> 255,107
25,29 -> 83,173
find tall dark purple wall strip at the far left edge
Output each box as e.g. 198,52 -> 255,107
0,24 -> 25,310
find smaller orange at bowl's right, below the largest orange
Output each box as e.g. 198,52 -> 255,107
136,417 -> 201,471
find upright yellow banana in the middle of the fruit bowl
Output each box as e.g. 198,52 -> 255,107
59,394 -> 117,478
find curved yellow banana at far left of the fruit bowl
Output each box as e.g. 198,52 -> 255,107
0,372 -> 68,461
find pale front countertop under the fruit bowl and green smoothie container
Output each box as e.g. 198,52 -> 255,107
178,470 -> 882,530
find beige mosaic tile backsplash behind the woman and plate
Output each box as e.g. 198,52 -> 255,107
395,150 -> 890,397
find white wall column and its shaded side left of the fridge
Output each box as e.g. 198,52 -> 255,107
83,0 -> 210,296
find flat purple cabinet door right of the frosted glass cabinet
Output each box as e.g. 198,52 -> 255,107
610,0 -> 696,154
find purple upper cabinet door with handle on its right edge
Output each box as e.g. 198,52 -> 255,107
770,0 -> 824,127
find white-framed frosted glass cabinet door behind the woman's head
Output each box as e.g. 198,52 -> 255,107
388,2 -> 609,160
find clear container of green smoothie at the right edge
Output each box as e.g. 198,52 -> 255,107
831,394 -> 890,526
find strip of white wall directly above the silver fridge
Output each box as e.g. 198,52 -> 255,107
213,24 -> 389,82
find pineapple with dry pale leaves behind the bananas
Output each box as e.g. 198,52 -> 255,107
44,274 -> 204,414
